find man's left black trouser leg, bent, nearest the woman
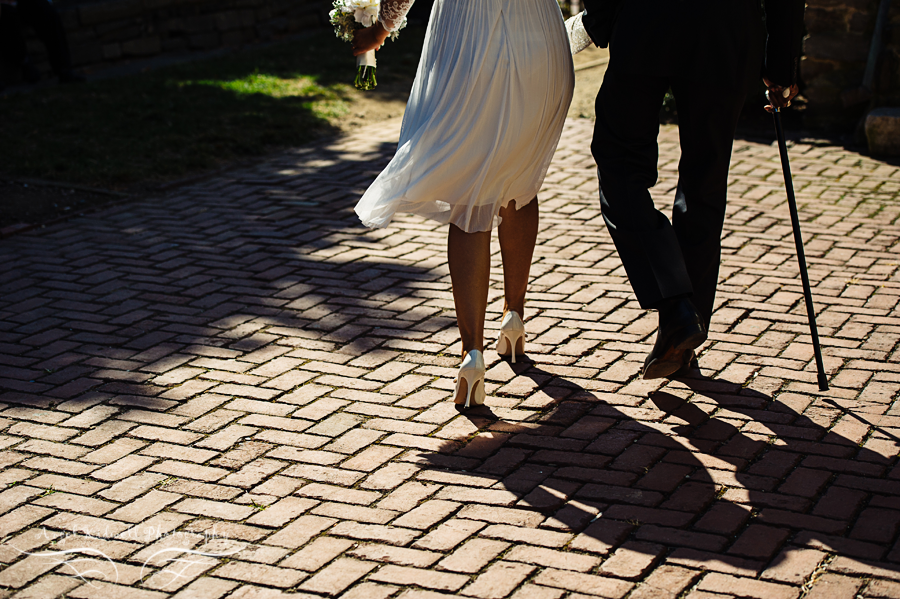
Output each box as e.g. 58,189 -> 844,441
591,69 -> 692,308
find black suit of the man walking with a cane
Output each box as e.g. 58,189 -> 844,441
583,0 -> 804,328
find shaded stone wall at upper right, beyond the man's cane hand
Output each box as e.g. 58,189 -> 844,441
801,0 -> 900,132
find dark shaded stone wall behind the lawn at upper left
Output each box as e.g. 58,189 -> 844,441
17,0 -> 330,78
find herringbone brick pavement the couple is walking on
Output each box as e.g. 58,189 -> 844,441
0,121 -> 900,599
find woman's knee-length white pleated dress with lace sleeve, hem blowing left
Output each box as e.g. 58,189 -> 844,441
356,0 -> 575,233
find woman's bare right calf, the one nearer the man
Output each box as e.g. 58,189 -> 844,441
499,198 -> 538,318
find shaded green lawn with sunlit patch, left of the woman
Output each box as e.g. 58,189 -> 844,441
0,28 -> 424,189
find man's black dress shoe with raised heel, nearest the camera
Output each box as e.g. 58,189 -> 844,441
644,298 -> 706,379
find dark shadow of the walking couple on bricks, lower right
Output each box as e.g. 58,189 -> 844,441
420,358 -> 900,596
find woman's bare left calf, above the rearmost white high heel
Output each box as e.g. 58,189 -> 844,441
447,225 -> 491,356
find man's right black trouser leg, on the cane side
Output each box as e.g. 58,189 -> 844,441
672,80 -> 746,330
